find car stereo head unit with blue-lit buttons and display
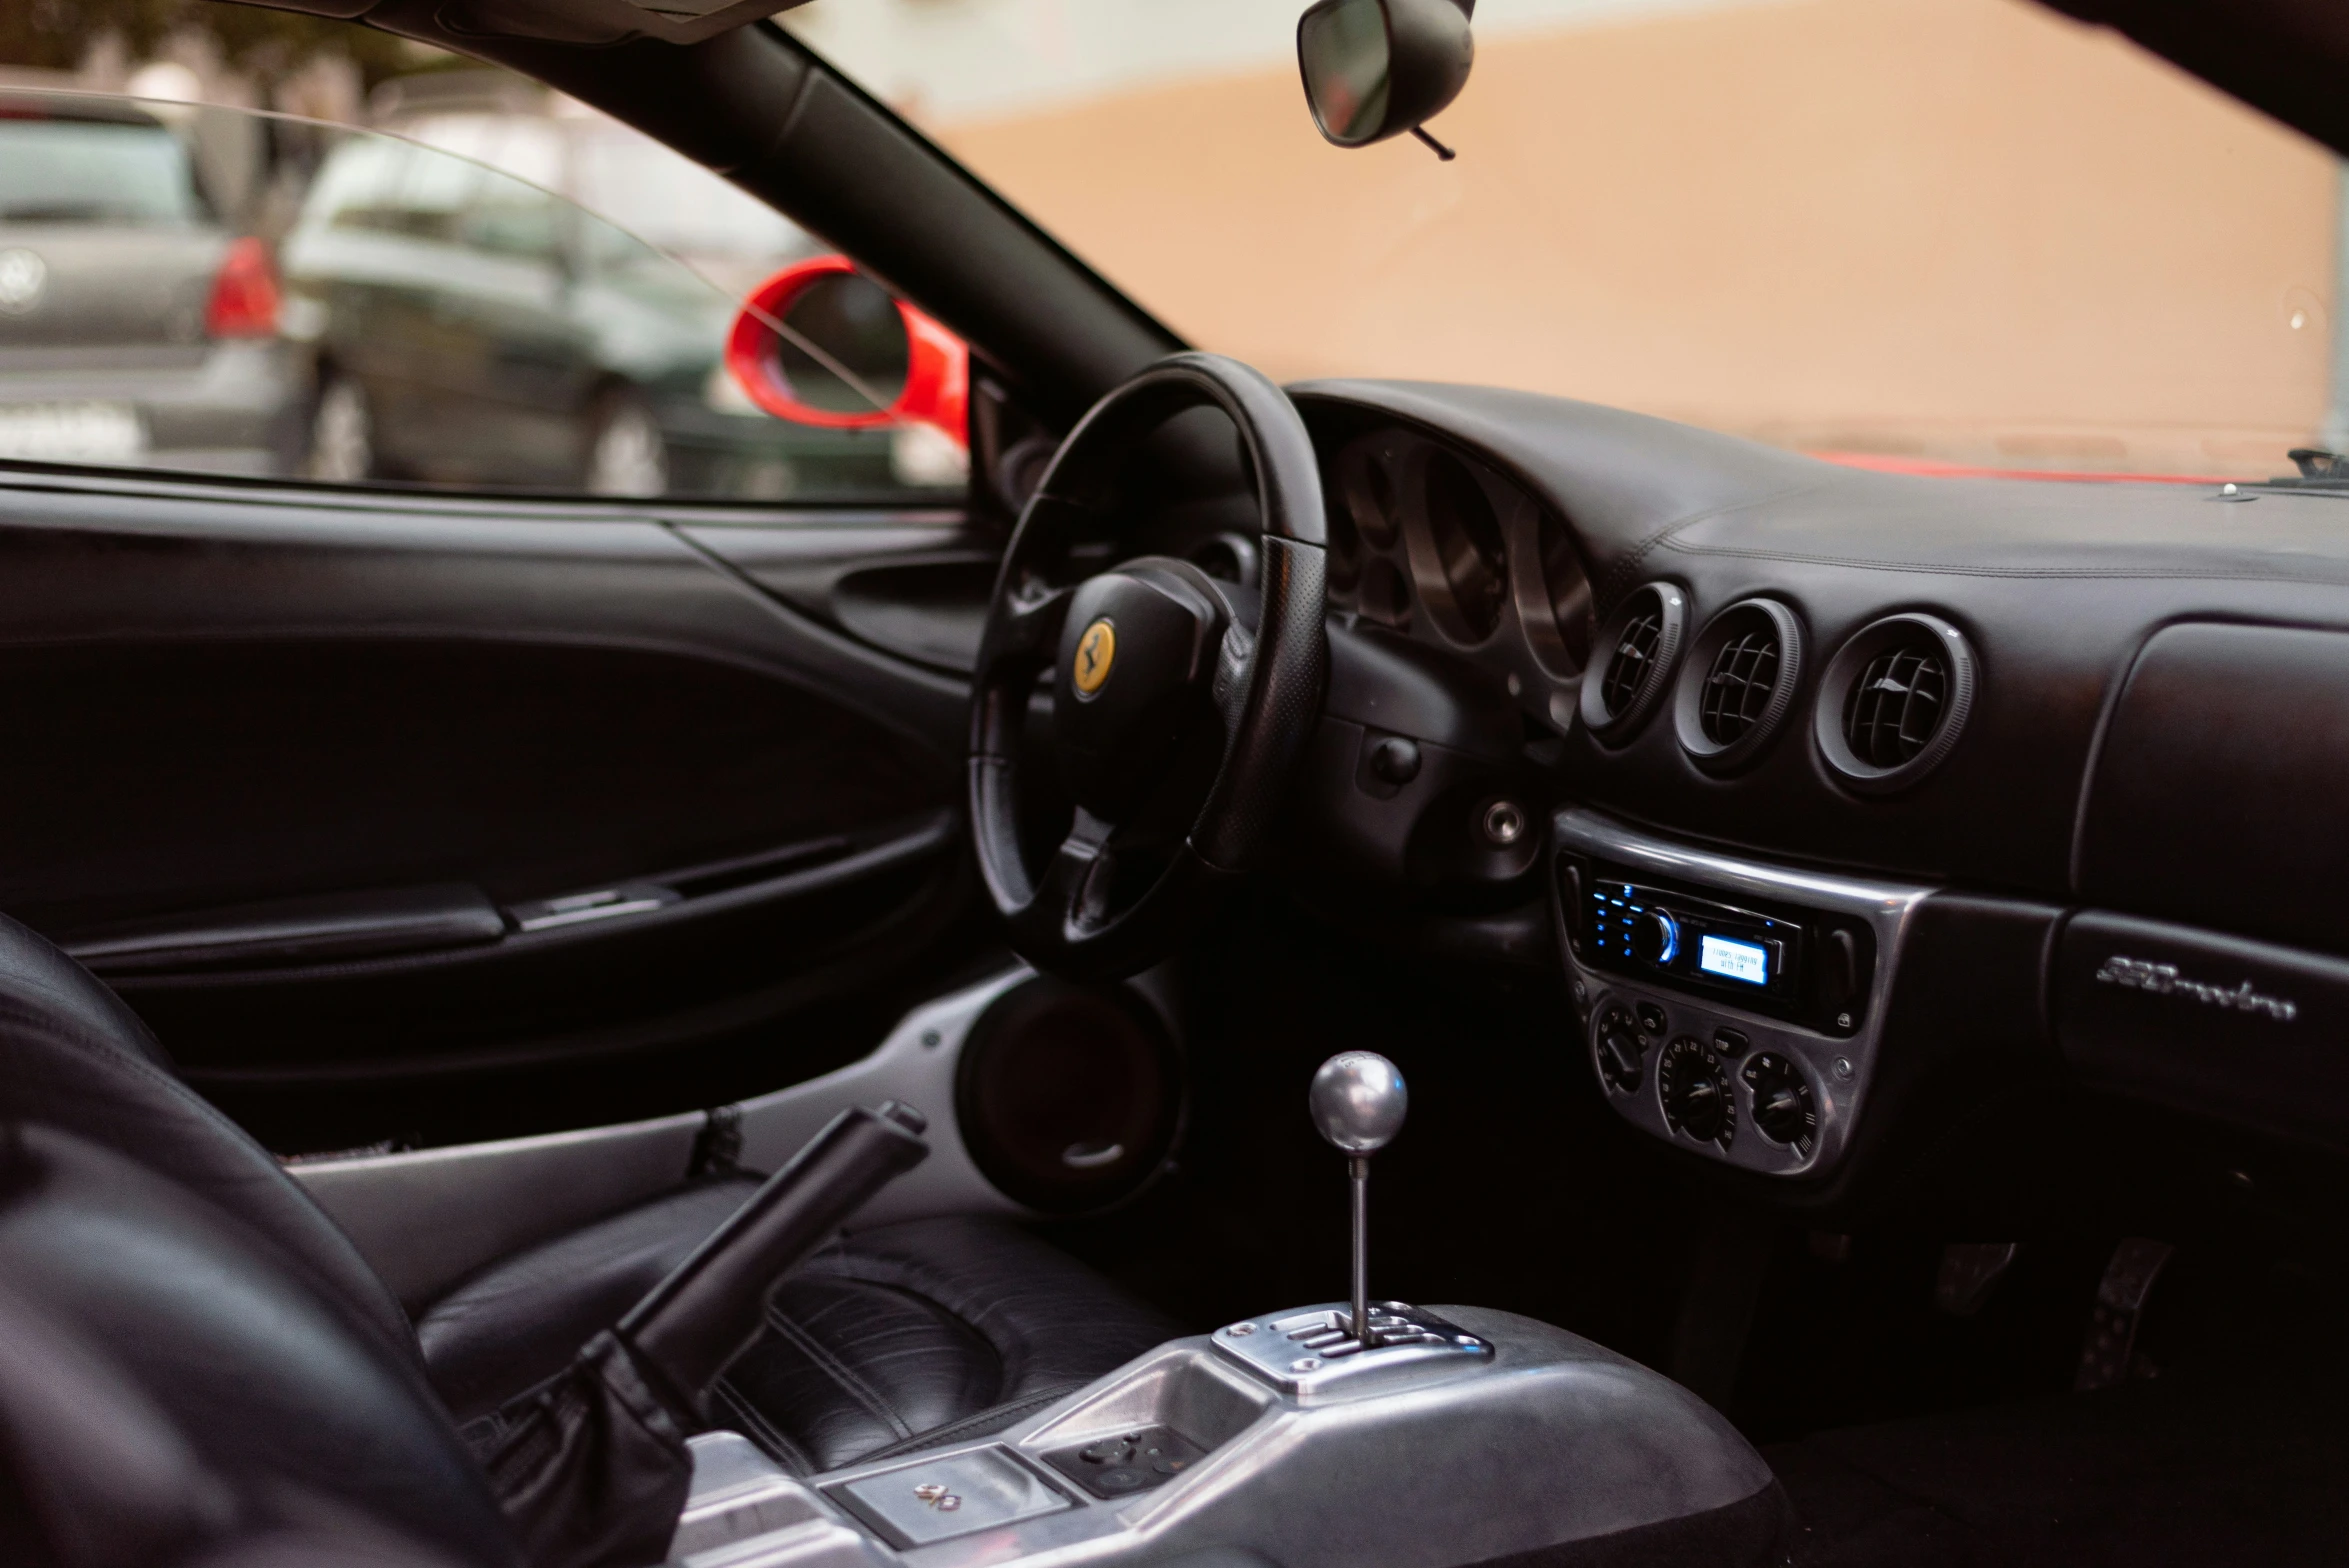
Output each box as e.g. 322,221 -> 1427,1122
1557,854 -> 1875,1033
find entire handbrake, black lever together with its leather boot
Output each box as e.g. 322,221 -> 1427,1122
484,1101 -> 930,1568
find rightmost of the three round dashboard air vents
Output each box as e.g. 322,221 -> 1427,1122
1811,613 -> 1976,796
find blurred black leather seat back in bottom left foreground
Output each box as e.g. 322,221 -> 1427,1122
0,1120 -> 521,1568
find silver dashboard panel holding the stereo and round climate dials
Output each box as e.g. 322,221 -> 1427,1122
1550,810 -> 1931,1176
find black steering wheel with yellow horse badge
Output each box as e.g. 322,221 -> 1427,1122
970,354 -> 1330,976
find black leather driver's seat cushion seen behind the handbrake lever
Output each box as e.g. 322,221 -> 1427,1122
416,1178 -> 1177,1472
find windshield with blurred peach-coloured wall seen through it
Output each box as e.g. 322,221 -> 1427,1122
782,0 -> 2349,477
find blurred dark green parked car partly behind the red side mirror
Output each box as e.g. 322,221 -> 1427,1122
284,110 -> 934,498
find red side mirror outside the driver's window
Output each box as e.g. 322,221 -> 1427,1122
726,256 -> 970,444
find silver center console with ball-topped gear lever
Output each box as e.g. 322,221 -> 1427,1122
669,1052 -> 1785,1568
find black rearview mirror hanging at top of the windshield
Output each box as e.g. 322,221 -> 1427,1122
1297,0 -> 1475,157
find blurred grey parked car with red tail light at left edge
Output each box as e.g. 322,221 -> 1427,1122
0,92 -> 303,474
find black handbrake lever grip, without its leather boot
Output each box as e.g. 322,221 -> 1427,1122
618,1101 -> 930,1408
